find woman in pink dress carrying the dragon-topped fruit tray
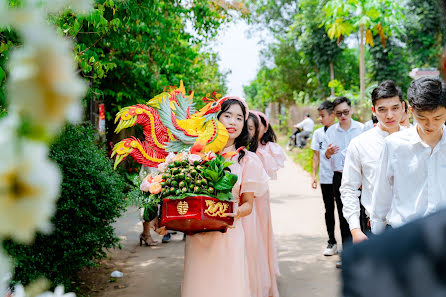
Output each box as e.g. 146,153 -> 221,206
181,97 -> 268,297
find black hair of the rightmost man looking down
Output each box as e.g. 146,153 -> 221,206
407,77 -> 446,111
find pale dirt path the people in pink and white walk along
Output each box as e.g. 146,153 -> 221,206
83,156 -> 340,297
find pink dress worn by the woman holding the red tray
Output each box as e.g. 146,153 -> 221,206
181,146 -> 268,297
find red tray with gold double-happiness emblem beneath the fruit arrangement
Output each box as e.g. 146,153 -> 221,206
161,196 -> 234,235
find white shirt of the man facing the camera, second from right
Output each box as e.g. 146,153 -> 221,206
339,126 -> 398,230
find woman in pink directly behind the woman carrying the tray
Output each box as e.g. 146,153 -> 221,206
248,111 -> 286,297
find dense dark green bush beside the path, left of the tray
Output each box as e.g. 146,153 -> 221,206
4,122 -> 125,288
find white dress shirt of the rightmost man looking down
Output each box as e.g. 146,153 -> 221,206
371,125 -> 446,234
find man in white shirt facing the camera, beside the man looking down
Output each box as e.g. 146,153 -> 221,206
340,80 -> 405,243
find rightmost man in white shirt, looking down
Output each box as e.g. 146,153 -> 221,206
371,77 -> 446,234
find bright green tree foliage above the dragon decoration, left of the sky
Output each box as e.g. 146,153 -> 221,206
0,0 -> 246,138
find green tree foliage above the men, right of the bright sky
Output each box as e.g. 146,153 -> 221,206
245,0 -> 446,107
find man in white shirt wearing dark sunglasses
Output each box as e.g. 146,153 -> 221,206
323,97 -> 364,244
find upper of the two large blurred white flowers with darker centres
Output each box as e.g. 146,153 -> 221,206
7,25 -> 87,135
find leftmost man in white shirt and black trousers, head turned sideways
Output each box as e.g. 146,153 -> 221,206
311,100 -> 338,256
